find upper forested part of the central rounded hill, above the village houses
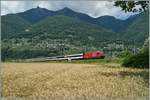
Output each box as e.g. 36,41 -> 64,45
13,15 -> 115,41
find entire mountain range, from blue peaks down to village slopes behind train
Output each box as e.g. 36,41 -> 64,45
2,7 -> 149,60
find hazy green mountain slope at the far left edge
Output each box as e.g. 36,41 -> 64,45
1,14 -> 30,39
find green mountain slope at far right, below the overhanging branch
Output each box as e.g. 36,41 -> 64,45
122,11 -> 149,44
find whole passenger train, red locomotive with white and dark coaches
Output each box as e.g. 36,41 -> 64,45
28,51 -> 105,61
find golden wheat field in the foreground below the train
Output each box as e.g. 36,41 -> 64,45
1,63 -> 149,100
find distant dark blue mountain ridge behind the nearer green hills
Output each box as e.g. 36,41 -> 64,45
8,7 -> 138,32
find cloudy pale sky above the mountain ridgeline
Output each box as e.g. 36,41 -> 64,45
1,0 -> 136,19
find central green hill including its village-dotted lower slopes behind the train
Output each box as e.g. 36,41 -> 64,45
2,15 -> 116,59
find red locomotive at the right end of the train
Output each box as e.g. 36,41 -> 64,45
83,51 -> 105,59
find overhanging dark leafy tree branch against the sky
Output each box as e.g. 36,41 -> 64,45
114,0 -> 149,12
